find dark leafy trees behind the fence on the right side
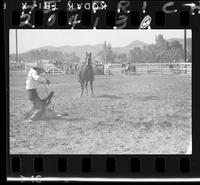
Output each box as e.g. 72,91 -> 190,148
98,35 -> 192,63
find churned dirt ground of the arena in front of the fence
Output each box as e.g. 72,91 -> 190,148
9,72 -> 192,154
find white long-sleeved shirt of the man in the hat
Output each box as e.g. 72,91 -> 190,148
26,68 -> 46,90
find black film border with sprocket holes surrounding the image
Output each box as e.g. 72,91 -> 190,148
4,0 -> 200,182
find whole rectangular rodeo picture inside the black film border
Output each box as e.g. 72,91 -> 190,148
9,29 -> 192,155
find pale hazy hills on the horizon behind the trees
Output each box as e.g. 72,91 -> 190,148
10,38 -> 192,62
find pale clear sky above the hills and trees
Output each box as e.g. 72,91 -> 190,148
9,29 -> 192,53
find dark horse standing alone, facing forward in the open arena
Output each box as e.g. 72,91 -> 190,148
78,52 -> 95,97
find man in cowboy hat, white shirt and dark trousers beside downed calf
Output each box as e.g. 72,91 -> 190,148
26,64 -> 50,120
